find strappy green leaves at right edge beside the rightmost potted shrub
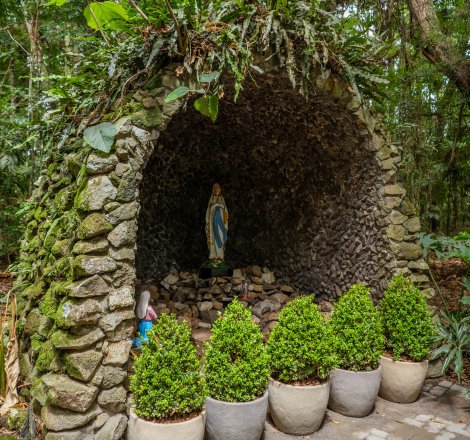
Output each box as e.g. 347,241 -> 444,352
432,308 -> 470,383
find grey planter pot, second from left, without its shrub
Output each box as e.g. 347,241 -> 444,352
206,392 -> 268,440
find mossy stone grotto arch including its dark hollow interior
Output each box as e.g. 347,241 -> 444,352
17,64 -> 427,439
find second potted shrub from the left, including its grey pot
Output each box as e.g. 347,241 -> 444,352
204,298 -> 269,440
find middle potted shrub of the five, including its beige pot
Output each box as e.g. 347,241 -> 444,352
267,296 -> 335,435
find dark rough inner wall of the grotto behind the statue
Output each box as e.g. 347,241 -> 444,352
136,71 -> 397,299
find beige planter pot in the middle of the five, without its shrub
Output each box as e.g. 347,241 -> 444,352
268,380 -> 330,435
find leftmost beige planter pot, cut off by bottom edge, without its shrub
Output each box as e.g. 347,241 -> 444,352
127,408 -> 205,440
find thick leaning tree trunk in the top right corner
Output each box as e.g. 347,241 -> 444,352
408,0 -> 470,100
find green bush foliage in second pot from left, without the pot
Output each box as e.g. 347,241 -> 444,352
204,298 -> 269,402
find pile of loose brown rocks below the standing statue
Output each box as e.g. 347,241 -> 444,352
140,266 -> 333,336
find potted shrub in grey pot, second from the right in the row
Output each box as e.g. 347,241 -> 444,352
328,284 -> 384,417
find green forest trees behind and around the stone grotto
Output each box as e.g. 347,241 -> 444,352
0,0 -> 470,264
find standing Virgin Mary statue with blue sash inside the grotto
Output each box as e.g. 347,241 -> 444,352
206,183 -> 228,264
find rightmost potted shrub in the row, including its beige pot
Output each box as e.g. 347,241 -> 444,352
379,276 -> 435,403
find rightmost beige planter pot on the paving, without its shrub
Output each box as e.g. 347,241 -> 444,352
379,356 -> 428,403
